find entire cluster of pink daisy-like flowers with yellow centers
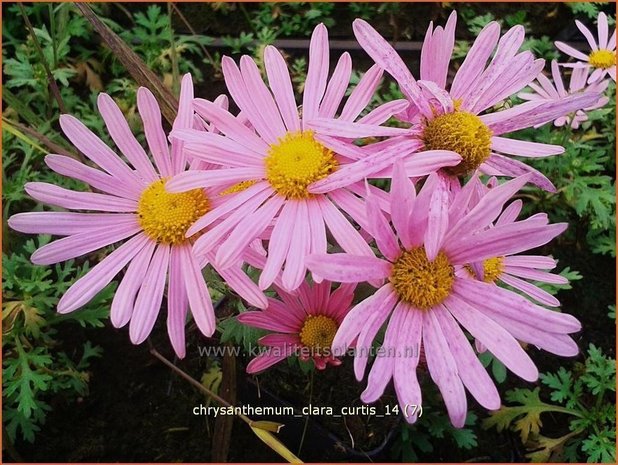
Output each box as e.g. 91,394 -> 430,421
9,13 -> 615,427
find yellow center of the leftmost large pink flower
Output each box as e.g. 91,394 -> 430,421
137,179 -> 209,245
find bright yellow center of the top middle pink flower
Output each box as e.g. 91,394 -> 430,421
265,131 -> 338,199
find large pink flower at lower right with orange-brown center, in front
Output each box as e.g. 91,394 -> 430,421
307,162 -> 580,427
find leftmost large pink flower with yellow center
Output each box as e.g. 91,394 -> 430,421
9,74 -> 267,357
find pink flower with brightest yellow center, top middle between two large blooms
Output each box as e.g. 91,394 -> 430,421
167,24 -> 460,291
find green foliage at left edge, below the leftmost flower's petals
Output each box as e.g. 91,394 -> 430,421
2,236 -> 115,442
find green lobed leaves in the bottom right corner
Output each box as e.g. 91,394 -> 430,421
483,344 -> 616,463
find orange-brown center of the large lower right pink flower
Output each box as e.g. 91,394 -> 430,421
390,246 -> 455,310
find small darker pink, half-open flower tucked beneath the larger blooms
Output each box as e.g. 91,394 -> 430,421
238,280 -> 356,373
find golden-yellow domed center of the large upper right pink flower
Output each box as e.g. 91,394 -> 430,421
423,111 -> 492,176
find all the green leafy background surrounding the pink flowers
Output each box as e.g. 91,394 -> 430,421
2,2 -> 616,462
